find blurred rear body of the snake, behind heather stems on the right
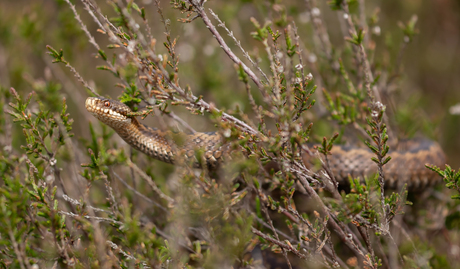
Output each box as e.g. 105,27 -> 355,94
314,138 -> 446,190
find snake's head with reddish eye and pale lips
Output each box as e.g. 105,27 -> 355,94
85,97 -> 132,127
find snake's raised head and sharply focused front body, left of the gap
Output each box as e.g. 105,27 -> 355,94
85,97 -> 229,168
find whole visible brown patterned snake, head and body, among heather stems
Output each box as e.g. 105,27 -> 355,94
86,97 -> 446,189
